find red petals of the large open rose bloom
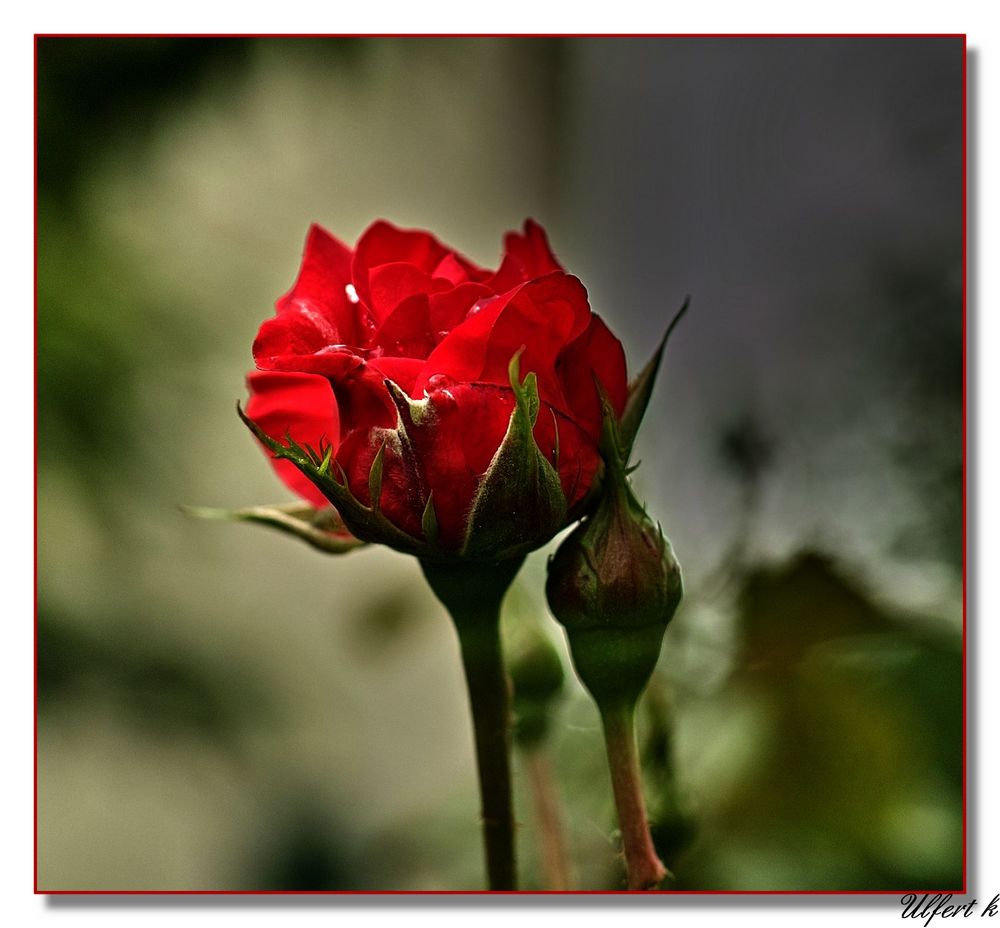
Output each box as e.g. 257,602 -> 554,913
247,220 -> 628,556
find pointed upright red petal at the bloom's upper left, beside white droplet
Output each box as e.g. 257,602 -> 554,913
276,224 -> 360,344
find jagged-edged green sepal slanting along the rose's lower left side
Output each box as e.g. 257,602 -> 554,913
236,403 -> 424,554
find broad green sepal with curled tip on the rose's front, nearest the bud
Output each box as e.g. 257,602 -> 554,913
461,351 -> 567,560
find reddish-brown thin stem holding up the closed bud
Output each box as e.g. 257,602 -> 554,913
599,701 -> 667,889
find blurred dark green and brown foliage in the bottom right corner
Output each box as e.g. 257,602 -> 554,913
675,551 -> 963,890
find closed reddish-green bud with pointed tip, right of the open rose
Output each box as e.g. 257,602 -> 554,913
545,402 -> 682,703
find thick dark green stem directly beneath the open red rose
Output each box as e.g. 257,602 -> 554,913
421,558 -> 524,890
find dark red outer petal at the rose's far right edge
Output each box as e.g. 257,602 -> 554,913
556,313 -> 628,443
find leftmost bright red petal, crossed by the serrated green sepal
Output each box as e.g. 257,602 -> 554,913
247,371 -> 340,506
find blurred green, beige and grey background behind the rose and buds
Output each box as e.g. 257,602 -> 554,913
37,38 -> 964,890
